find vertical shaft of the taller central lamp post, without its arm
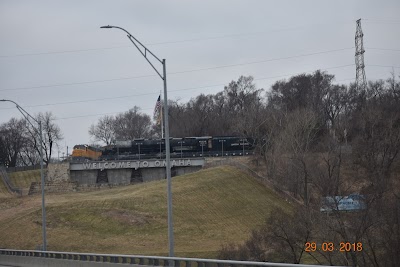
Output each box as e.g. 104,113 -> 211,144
163,59 -> 174,260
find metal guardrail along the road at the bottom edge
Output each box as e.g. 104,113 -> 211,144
0,249 -> 344,267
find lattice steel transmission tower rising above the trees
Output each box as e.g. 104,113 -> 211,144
355,19 -> 367,90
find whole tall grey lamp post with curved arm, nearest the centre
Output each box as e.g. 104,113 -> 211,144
100,25 -> 174,257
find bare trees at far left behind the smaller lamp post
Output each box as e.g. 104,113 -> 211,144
0,112 -> 63,167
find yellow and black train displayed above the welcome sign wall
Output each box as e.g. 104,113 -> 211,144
72,136 -> 255,160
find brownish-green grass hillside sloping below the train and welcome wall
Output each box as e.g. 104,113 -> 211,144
0,166 -> 292,257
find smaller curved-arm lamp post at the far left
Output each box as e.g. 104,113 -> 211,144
0,99 -> 47,251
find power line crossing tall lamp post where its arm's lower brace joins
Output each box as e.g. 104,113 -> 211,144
0,47 -> 354,91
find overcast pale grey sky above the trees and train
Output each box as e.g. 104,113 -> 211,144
0,0 -> 400,157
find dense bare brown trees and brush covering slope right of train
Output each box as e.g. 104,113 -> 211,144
216,71 -> 400,266
